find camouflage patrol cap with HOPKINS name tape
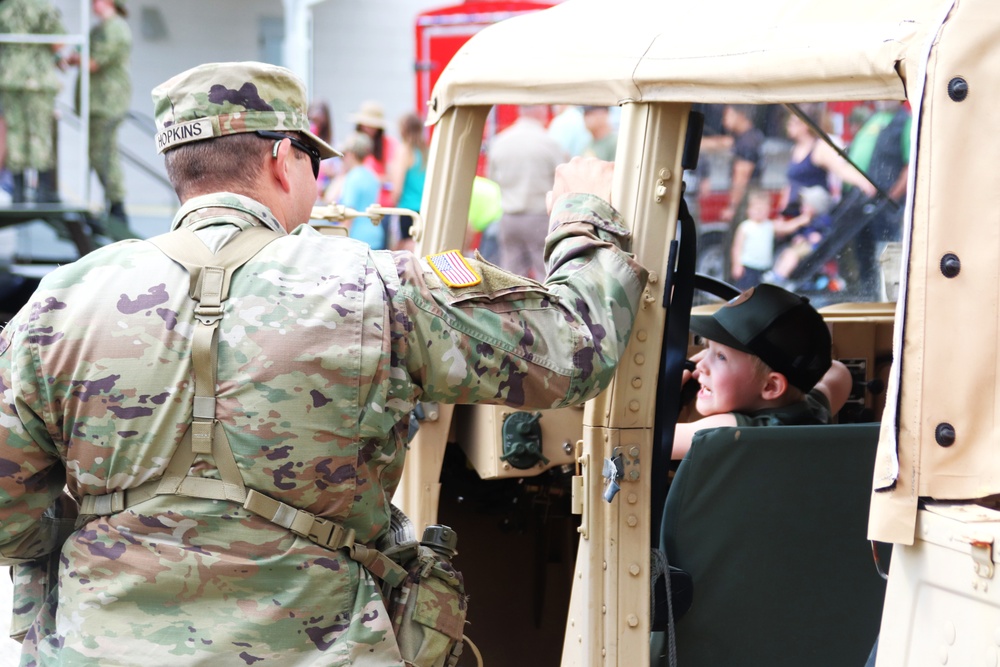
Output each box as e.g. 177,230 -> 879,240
153,62 -> 340,158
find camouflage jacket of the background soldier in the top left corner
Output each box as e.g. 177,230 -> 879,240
0,0 -> 66,93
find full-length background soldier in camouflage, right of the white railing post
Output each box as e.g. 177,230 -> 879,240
65,0 -> 136,241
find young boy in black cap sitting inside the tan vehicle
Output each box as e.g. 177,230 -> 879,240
672,284 -> 852,459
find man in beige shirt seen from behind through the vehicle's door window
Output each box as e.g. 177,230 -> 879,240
487,106 -> 566,280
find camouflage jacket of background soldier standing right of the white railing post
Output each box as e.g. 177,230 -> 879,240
76,14 -> 132,117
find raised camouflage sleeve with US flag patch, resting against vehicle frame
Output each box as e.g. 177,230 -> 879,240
393,195 -> 647,408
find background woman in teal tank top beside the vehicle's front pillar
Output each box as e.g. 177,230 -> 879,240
389,113 -> 427,250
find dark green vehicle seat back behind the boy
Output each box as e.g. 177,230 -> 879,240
653,423 -> 887,667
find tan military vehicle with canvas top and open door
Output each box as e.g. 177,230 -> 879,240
378,0 -> 1000,667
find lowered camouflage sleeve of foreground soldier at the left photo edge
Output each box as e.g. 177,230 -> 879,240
0,311 -> 65,565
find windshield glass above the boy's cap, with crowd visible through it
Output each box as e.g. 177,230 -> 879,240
685,101 -> 911,306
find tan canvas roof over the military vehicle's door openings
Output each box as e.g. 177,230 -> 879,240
431,0 -> 952,120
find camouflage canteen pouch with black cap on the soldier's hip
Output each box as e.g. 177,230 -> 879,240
387,545 -> 467,667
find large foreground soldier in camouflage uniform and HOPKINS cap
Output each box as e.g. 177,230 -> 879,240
0,63 -> 646,667
